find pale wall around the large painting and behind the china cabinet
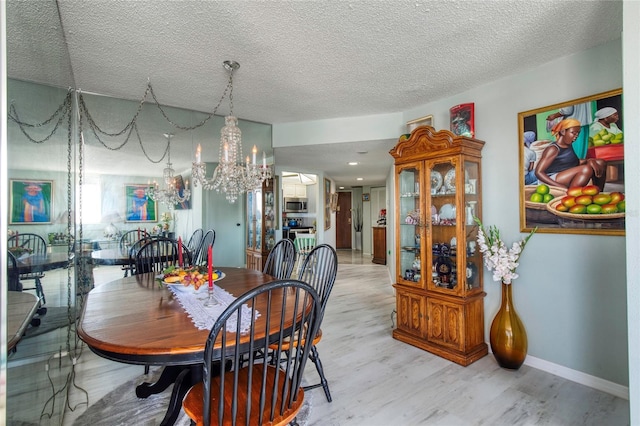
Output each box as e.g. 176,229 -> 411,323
273,40 -> 630,390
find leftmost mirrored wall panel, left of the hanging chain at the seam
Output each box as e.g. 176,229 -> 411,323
0,1 -> 81,424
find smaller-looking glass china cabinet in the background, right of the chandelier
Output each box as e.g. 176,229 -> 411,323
247,179 -> 278,271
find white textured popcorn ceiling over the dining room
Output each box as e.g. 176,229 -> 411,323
7,0 -> 622,188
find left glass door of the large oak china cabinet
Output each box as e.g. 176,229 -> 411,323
396,164 -> 424,287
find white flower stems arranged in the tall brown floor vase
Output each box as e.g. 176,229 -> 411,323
473,217 -> 538,284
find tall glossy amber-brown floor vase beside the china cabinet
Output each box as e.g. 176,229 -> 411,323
489,283 -> 527,370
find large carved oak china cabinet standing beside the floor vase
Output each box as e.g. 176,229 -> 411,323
390,126 -> 488,366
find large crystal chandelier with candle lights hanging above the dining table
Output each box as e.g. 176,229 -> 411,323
192,61 -> 271,203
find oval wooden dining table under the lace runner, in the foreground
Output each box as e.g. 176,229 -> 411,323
77,268 -> 282,425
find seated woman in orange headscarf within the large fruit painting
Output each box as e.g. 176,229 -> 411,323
535,119 -> 606,191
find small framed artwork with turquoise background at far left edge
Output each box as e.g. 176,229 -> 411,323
9,179 -> 53,225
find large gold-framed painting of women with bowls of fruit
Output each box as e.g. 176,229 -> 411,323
518,89 -> 626,236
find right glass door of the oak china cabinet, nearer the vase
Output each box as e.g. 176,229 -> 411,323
425,159 -> 464,293
